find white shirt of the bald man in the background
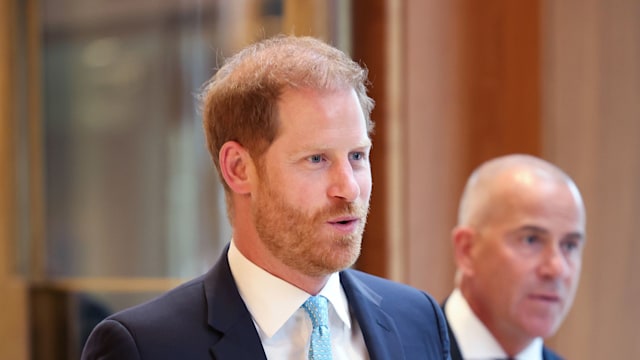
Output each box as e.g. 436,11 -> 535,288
444,289 -> 543,360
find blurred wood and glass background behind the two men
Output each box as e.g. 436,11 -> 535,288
0,0 -> 640,360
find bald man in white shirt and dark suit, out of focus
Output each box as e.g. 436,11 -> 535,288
443,154 -> 586,360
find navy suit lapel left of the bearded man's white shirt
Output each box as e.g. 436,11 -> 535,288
204,246 -> 267,360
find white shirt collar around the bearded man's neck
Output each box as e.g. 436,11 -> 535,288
227,240 -> 351,337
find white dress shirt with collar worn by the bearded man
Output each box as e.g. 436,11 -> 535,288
227,241 -> 369,360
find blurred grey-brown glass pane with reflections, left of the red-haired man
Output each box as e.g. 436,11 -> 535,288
42,0 -> 282,278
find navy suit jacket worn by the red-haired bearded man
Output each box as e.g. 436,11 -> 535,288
82,251 -> 449,360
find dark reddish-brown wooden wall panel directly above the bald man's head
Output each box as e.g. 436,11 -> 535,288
459,0 -> 542,171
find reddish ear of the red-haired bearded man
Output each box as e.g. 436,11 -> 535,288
219,141 -> 254,194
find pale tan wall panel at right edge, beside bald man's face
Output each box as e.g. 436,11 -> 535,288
543,0 -> 640,360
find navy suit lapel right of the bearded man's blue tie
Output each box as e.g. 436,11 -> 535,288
340,270 -> 405,360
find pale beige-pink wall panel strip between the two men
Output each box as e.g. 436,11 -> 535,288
399,0 -> 467,300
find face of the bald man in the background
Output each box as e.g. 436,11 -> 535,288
464,172 -> 585,341
